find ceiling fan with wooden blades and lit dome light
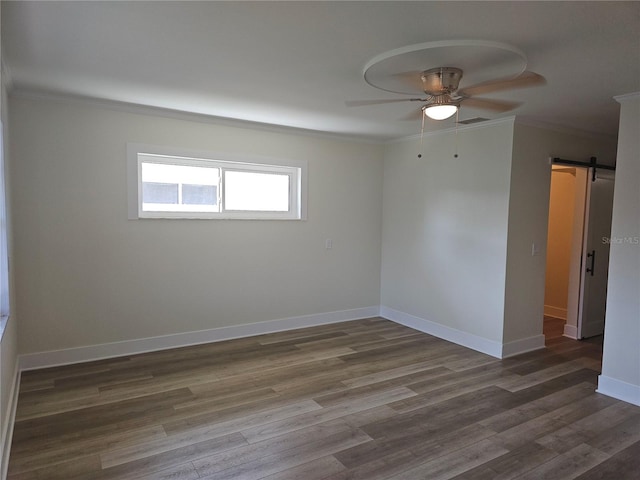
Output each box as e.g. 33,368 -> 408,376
345,67 -> 545,120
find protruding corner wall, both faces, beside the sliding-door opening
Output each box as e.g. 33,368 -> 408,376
381,118 -> 615,357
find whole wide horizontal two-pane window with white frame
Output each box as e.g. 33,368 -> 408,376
128,144 -> 306,220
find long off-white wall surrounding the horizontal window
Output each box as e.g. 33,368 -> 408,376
10,97 -> 382,354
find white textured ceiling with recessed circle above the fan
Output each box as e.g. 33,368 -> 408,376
2,1 -> 640,141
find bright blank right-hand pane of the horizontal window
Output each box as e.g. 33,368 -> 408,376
224,171 -> 289,212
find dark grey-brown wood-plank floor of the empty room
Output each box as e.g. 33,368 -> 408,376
9,318 -> 640,480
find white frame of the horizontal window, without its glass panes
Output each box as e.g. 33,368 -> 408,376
127,143 -> 307,220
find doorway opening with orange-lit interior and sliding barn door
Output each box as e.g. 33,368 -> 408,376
543,162 -> 614,340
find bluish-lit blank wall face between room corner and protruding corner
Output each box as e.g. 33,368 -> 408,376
381,119 -> 513,356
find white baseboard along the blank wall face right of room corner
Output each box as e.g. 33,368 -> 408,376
380,306 -> 503,358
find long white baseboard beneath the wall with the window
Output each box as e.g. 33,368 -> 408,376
19,306 -> 380,370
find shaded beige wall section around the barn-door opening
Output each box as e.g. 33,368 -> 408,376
504,122 -> 616,351
